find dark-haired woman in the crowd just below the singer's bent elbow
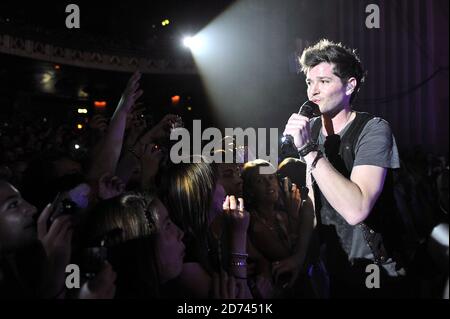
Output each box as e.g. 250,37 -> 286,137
242,160 -> 312,296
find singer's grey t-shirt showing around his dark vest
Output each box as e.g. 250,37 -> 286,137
311,117 -> 400,276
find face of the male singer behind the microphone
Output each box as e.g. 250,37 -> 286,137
306,62 -> 350,114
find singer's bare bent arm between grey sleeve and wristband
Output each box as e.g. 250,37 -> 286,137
305,152 -> 386,225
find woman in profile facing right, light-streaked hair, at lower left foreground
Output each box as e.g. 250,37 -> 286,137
82,193 -> 184,298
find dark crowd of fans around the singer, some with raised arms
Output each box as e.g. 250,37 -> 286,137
0,73 -> 449,299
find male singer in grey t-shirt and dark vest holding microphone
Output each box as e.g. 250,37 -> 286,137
284,40 -> 412,298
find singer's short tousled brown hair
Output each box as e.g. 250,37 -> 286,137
298,39 -> 366,103
